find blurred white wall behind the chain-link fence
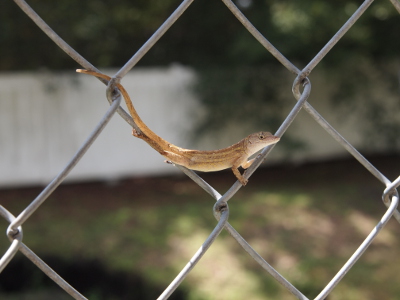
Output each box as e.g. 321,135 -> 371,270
0,66 -> 390,187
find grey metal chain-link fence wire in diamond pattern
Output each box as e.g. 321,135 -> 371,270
0,0 -> 400,300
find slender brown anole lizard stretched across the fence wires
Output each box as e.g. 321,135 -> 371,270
76,69 -> 280,185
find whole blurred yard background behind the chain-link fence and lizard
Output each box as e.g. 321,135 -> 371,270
0,0 -> 400,300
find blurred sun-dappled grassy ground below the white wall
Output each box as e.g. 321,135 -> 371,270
0,156 -> 400,300
